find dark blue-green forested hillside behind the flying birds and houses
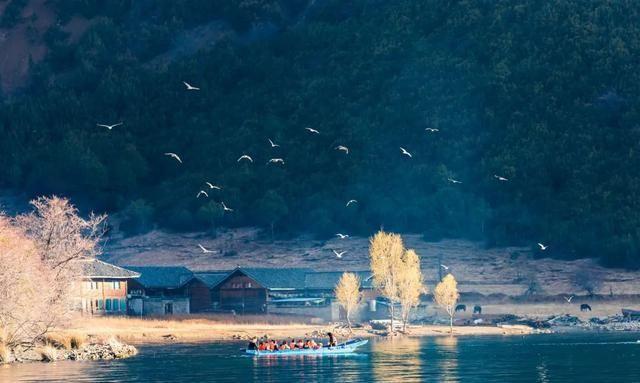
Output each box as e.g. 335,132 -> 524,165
0,0 -> 640,267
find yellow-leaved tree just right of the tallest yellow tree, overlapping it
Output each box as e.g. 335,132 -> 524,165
398,249 -> 426,332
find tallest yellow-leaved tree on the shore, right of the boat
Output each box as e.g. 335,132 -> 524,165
369,231 -> 405,332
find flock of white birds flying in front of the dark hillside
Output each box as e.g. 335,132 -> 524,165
96,81 -> 548,260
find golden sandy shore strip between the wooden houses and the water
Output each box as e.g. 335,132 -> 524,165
59,317 -> 531,344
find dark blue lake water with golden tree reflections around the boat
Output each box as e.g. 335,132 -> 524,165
0,333 -> 640,383
